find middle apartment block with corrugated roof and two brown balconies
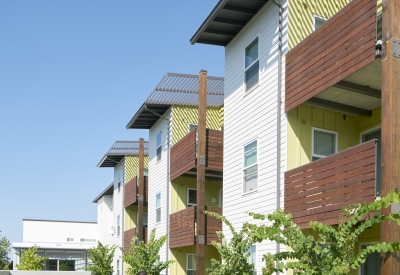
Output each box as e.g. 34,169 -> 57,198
127,73 -> 224,274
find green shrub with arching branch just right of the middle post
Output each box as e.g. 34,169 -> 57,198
205,211 -> 254,275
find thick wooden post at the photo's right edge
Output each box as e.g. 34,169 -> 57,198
381,0 -> 400,275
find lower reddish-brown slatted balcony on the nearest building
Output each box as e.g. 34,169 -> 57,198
285,140 -> 380,228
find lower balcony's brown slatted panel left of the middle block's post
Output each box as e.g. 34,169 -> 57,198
169,206 -> 196,248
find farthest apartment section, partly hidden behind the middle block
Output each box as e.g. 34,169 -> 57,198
93,141 -> 149,275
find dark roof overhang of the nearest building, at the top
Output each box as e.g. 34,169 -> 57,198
190,0 -> 269,46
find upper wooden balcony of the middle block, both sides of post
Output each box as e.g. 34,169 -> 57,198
170,129 -> 224,180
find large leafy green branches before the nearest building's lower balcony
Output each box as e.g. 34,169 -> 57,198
245,192 -> 400,275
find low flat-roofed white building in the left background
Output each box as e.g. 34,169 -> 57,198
13,219 -> 97,271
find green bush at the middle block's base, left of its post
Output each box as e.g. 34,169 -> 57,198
121,229 -> 174,275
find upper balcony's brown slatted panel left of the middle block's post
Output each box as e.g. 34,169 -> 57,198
170,130 -> 196,180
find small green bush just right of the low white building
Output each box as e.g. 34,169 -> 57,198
84,242 -> 117,275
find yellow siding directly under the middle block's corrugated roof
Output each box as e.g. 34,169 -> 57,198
172,106 -> 223,145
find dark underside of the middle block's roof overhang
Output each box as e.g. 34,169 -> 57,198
126,103 -> 171,129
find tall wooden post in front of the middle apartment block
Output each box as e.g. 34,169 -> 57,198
196,70 -> 207,274
